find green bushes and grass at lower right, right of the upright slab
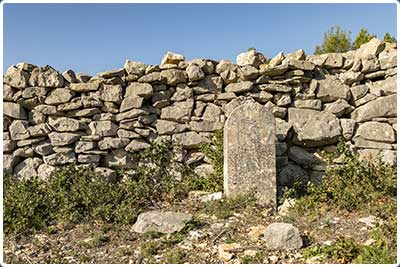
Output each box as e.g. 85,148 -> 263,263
289,142 -> 397,263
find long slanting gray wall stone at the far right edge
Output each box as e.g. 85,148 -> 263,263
351,94 -> 397,122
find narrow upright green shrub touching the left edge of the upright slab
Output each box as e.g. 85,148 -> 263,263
198,130 -> 224,192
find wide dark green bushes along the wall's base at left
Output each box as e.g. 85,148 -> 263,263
4,143 -> 205,236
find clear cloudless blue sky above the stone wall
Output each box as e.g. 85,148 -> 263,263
3,3 -> 396,74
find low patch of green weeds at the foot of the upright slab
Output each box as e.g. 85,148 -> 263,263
203,194 -> 255,219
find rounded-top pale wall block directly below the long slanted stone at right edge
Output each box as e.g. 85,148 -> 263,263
355,121 -> 396,143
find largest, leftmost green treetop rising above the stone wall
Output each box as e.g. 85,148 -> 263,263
314,26 -> 351,55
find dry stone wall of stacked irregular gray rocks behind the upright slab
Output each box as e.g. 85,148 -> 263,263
3,39 -> 397,191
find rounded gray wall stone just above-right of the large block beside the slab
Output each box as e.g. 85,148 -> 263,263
317,76 -> 350,102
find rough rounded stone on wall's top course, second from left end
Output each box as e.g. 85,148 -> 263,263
29,65 -> 64,88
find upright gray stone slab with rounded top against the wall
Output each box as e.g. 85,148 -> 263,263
224,102 -> 276,205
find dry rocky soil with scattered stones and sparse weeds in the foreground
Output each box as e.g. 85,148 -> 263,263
4,192 -> 374,264
